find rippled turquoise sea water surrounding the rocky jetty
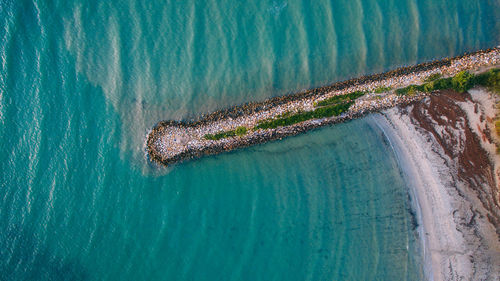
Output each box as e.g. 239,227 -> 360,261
0,0 -> 500,280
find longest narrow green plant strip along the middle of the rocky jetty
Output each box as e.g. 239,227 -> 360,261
254,101 -> 354,130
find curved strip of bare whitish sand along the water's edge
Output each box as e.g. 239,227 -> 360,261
371,104 -> 496,280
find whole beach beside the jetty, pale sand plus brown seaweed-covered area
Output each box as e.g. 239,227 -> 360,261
376,90 -> 500,280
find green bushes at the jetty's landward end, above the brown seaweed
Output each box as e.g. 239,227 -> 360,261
396,69 -> 500,95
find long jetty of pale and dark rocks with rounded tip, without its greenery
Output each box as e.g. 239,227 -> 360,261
146,47 -> 500,166
